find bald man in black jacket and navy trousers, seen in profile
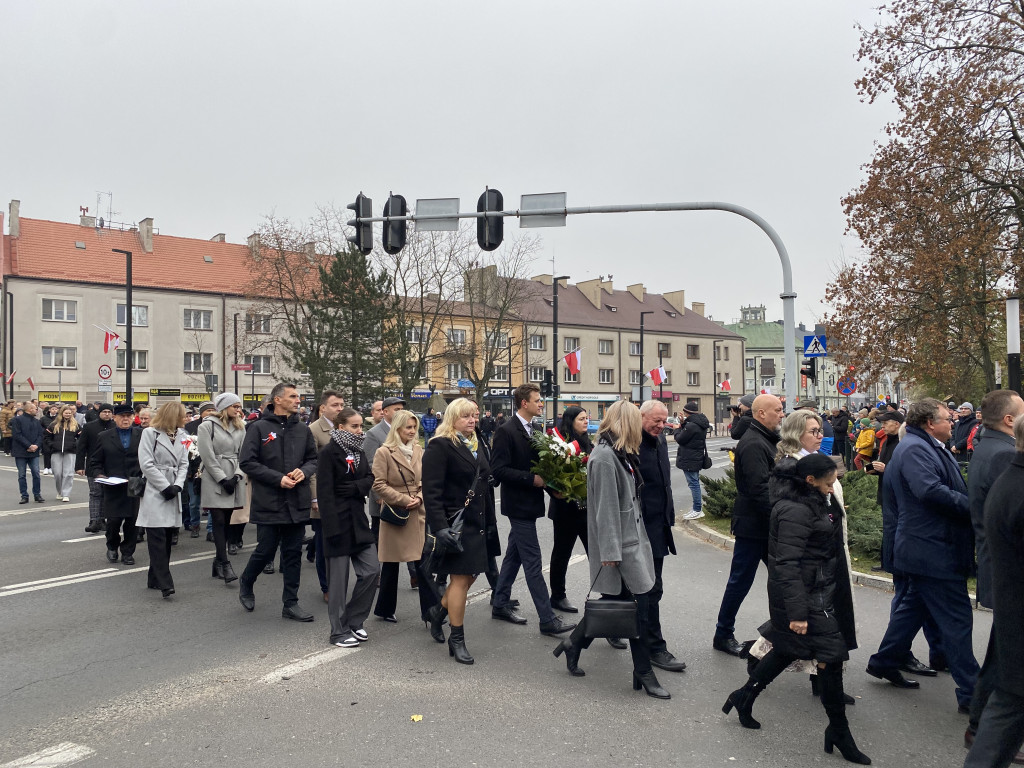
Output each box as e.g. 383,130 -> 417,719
712,394 -> 783,656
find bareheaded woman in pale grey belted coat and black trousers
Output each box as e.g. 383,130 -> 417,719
135,402 -> 188,598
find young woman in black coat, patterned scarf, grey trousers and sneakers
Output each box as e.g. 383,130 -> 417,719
316,408 -> 380,648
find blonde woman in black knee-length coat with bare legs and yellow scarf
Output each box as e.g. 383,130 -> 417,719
423,397 -> 498,664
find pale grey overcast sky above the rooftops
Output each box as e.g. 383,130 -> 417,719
0,0 -> 893,323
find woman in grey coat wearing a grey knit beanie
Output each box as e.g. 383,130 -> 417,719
196,392 -> 246,584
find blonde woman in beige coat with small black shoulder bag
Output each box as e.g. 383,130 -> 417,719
373,411 -> 430,622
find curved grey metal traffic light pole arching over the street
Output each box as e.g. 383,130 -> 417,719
348,194 -> 800,402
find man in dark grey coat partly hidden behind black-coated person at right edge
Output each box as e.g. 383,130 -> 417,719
965,389 -> 1024,741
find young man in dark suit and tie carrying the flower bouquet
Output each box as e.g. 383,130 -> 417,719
490,384 -> 575,636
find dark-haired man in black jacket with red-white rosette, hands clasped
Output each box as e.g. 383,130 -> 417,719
239,382 -> 316,622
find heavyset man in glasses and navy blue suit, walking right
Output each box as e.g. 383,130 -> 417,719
867,397 -> 978,714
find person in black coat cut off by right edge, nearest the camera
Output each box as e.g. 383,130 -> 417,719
964,417 -> 1024,768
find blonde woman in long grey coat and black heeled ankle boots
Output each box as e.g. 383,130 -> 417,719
554,400 -> 671,698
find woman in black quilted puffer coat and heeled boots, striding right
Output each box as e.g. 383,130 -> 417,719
722,454 -> 871,765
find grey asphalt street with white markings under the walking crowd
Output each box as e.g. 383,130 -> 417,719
0,439 -> 990,768
